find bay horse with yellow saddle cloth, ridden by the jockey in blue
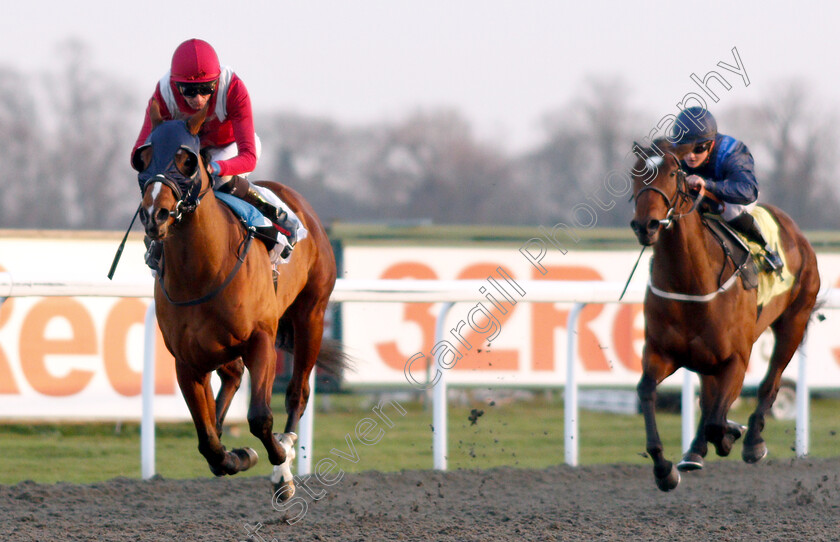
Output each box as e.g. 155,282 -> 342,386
630,140 -> 820,491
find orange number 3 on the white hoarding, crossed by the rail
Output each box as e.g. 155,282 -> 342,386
375,262 -> 438,372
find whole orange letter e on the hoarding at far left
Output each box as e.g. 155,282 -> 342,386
20,297 -> 96,397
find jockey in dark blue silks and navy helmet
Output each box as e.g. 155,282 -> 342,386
669,107 -> 784,271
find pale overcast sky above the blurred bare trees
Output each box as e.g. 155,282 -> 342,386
0,0 -> 840,148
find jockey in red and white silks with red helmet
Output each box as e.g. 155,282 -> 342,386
132,39 -> 301,269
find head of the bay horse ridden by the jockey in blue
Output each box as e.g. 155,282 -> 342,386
630,142 -> 691,246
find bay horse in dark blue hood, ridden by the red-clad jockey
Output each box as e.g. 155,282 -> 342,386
132,104 -> 346,500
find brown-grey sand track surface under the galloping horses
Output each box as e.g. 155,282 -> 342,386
0,458 -> 840,542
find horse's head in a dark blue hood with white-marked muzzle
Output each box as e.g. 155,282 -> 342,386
131,101 -> 210,240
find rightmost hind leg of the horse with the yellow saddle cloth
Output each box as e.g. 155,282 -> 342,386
741,309 -> 810,463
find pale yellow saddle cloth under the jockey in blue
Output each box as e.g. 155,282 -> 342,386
705,206 -> 795,307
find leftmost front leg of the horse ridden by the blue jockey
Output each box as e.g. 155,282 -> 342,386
636,347 -> 680,491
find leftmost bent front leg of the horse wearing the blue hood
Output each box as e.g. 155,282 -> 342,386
175,366 -> 257,476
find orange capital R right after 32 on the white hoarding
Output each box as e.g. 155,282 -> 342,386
531,266 -> 610,371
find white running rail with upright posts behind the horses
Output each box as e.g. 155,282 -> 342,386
0,272 -> 828,478
